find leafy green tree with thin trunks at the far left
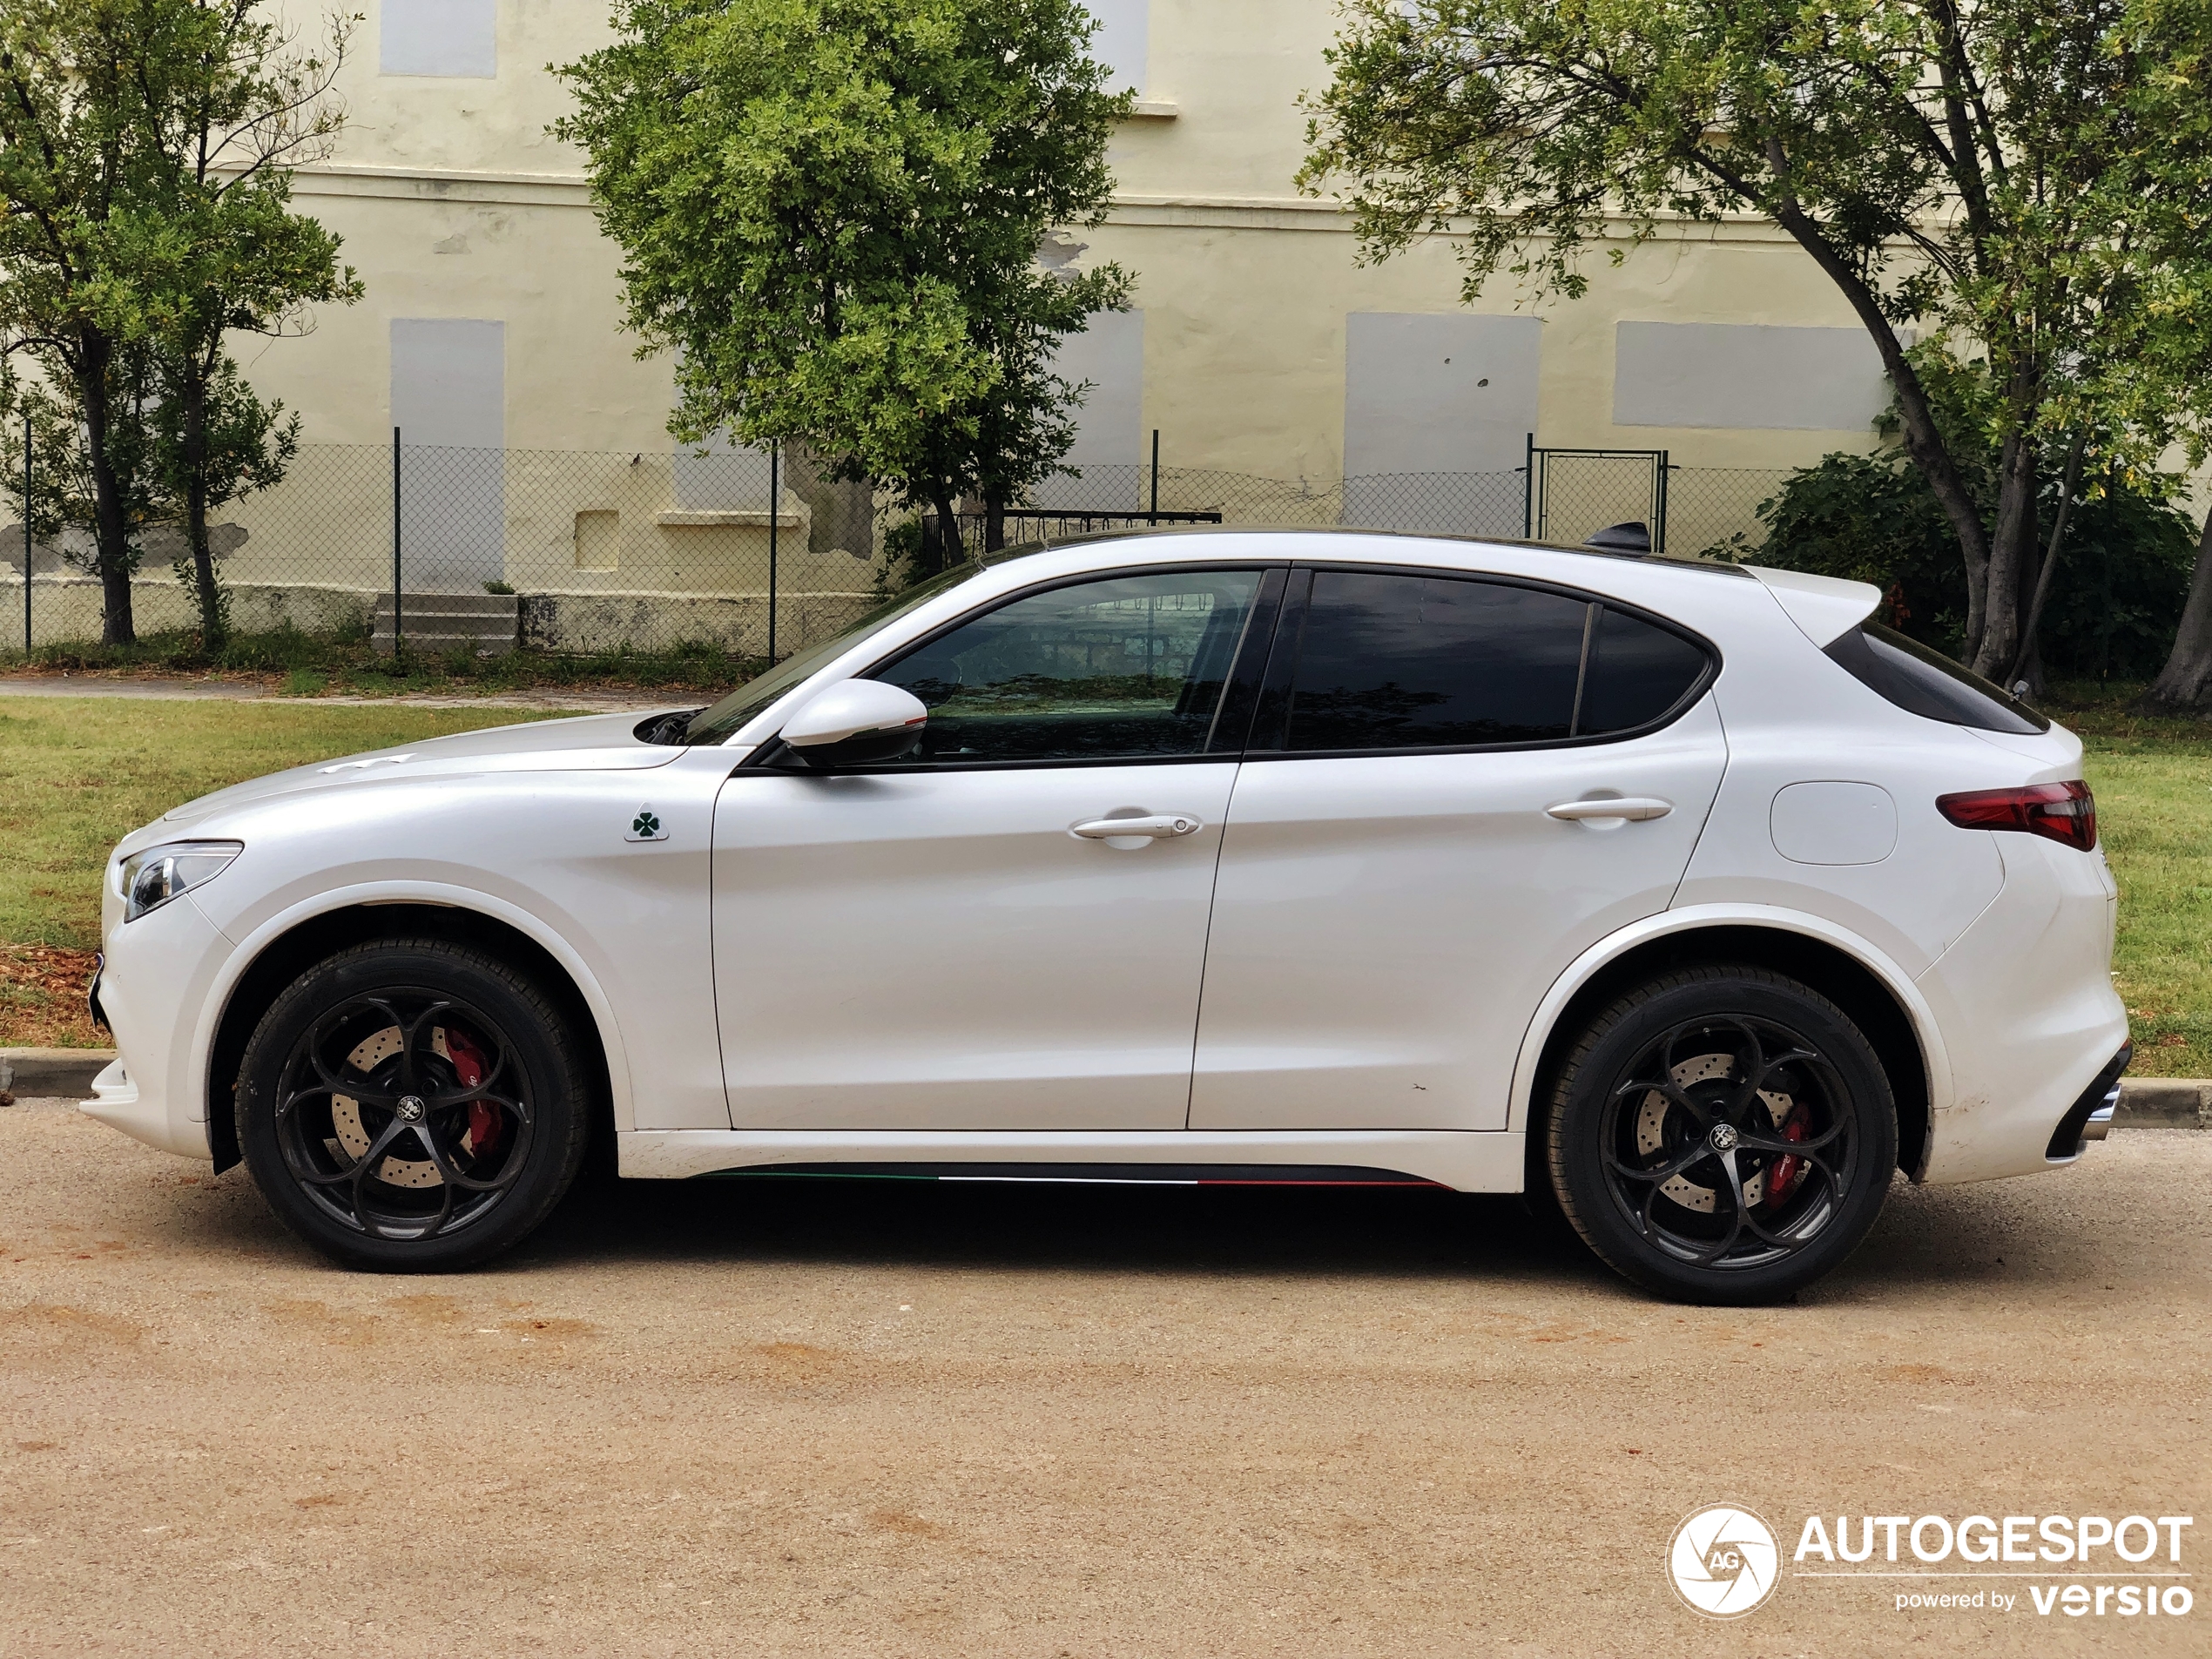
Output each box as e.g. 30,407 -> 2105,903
0,0 -> 361,644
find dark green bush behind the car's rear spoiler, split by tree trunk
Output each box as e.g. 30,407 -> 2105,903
1721,451 -> 2196,679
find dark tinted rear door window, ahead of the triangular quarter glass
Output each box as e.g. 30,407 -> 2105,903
1283,570 -> 1590,752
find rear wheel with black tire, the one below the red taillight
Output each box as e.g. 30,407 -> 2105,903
1544,967 -> 1898,1305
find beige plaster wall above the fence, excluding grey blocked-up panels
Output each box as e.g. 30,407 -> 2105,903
247,0 -> 1869,473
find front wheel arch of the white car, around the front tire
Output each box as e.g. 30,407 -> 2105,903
206,898 -> 626,1175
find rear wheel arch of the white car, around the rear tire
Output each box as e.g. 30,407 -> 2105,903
1508,911 -> 1951,1181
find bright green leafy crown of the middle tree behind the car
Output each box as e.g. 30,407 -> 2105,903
556,0 -> 1128,583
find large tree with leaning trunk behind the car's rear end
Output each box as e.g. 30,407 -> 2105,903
1301,0 -> 2212,677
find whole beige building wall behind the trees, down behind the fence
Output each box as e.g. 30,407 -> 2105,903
73,0 -> 1878,646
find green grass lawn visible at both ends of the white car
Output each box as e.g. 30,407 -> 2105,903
0,690 -> 2212,1077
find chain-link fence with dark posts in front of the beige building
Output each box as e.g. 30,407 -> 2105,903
0,442 -> 1787,657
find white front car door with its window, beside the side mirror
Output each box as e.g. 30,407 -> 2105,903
714,569 -> 1283,1130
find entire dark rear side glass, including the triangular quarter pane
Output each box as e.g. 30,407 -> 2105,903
1254,570 -> 1710,754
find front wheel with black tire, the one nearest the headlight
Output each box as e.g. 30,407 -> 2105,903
237,941 -> 590,1272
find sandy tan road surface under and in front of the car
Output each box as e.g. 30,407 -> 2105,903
0,1102 -> 2212,1659
